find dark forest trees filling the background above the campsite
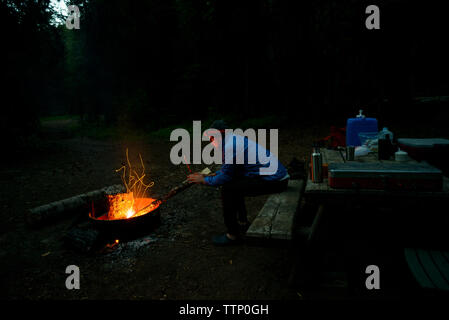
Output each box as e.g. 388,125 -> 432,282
0,0 -> 449,146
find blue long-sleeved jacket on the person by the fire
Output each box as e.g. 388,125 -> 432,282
204,134 -> 288,186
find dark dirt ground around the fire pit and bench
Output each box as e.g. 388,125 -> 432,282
0,117 -> 440,300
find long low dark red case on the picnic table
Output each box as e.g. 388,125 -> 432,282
328,162 -> 443,191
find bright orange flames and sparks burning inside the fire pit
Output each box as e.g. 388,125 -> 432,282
92,149 -> 160,220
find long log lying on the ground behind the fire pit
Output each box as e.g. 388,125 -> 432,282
27,185 -> 126,225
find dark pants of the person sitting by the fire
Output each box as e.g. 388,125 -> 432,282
221,177 -> 288,235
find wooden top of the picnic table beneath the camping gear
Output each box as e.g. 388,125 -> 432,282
305,149 -> 449,198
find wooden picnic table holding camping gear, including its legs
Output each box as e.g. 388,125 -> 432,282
299,149 -> 449,292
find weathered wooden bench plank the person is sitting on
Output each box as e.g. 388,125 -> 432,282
246,180 -> 305,240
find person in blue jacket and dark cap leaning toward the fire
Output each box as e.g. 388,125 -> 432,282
187,120 -> 290,246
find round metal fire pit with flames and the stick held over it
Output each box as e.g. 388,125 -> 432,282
60,149 -> 210,251
